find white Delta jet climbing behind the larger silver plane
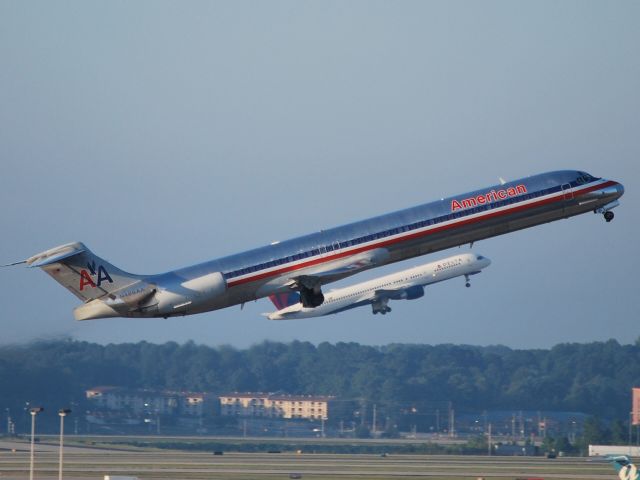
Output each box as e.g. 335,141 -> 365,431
265,253 -> 491,320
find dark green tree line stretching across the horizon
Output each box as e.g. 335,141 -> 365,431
0,340 -> 640,420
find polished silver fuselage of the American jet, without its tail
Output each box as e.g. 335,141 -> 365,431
141,171 -> 624,316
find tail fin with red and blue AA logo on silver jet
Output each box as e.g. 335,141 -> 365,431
25,242 -> 140,302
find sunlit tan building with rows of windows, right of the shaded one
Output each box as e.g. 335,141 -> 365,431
219,393 -> 334,420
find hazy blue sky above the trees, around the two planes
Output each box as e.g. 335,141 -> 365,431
0,0 -> 640,347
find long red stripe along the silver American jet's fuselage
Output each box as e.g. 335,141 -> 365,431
228,180 -> 617,287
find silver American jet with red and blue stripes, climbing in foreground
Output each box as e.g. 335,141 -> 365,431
10,170 -> 624,320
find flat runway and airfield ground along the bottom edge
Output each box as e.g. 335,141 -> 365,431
0,441 -> 617,480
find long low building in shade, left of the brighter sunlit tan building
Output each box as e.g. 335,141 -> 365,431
86,386 -> 213,417
